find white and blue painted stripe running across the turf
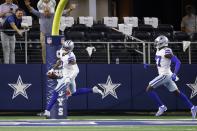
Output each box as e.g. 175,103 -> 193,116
0,119 -> 197,127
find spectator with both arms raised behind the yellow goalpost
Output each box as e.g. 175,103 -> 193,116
25,0 -> 76,64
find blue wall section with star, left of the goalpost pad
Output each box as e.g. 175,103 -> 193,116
0,65 -> 44,110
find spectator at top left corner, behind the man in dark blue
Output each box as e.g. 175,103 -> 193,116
0,0 -> 18,21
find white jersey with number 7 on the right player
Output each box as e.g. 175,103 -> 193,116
155,47 -> 173,75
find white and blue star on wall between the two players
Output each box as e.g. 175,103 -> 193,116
98,76 -> 121,99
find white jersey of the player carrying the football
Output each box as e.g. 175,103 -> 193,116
60,52 -> 76,77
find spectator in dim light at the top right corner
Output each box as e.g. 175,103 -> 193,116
181,5 -> 197,34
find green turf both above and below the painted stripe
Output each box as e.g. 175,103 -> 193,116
0,116 -> 197,131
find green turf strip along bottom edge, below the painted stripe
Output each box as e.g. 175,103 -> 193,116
0,126 -> 197,131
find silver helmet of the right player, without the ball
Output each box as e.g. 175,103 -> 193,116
154,35 -> 168,49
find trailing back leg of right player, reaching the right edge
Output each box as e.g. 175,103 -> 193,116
168,80 -> 197,119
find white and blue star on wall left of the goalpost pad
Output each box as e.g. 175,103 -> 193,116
8,75 -> 31,99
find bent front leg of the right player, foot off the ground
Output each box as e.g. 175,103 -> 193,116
146,75 -> 167,116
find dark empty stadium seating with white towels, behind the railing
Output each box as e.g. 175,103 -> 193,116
0,14 -> 197,64
